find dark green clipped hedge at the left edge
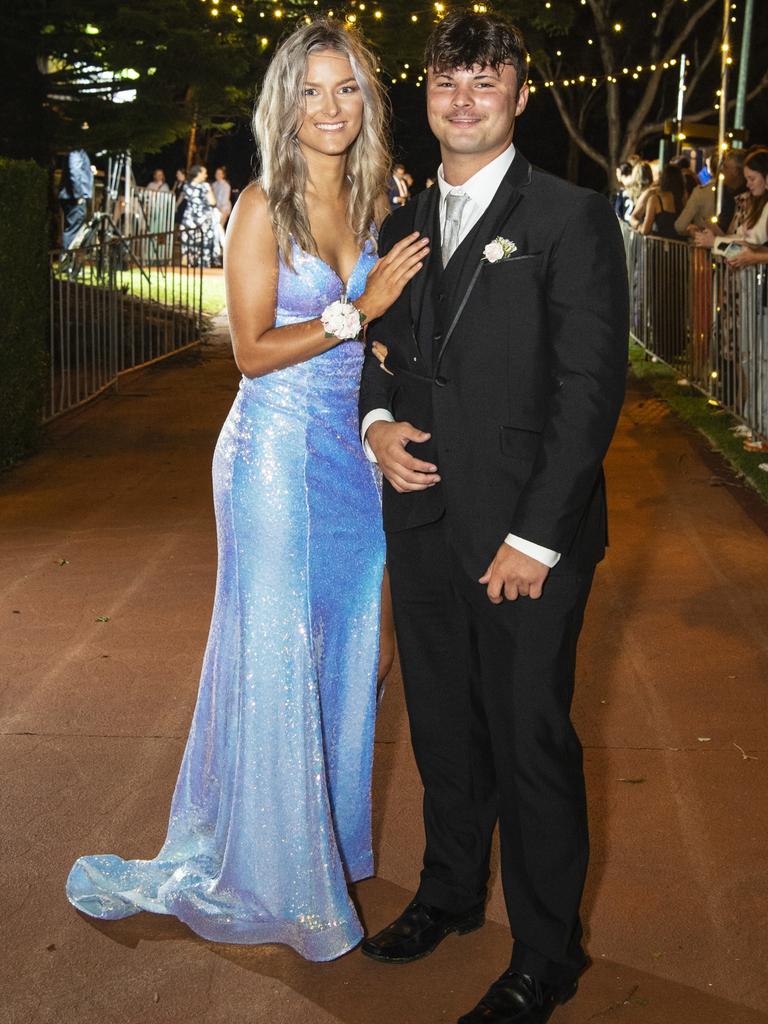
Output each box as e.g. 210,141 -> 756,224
0,160 -> 48,467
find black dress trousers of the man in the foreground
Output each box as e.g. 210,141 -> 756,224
387,516 -> 594,982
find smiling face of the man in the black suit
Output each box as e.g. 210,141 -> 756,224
427,65 -> 528,162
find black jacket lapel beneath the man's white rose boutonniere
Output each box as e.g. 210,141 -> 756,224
435,151 -> 531,373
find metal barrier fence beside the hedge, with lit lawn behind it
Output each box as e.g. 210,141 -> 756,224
43,231 -> 203,422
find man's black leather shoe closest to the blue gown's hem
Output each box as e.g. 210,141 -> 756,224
361,900 -> 485,964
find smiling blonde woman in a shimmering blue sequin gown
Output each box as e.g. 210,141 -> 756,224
67,23 -> 434,961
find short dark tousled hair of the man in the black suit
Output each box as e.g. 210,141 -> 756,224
424,10 -> 528,89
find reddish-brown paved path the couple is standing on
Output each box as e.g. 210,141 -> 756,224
0,329 -> 768,1024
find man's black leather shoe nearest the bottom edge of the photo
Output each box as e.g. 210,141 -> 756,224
459,970 -> 579,1024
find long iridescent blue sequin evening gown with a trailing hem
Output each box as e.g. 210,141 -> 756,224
67,235 -> 384,961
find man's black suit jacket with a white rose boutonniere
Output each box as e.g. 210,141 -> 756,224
359,151 -> 629,579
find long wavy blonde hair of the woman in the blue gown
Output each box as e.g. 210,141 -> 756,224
253,18 -> 391,266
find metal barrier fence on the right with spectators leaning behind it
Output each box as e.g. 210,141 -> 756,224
622,224 -> 768,437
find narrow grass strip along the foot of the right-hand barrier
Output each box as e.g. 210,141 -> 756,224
630,342 -> 768,501
